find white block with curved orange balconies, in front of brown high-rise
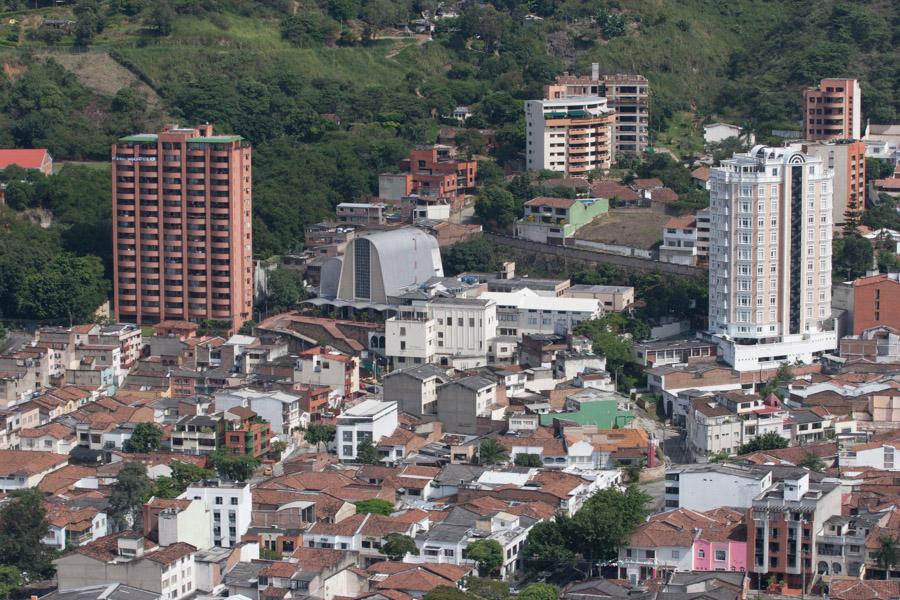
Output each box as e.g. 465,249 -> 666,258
525,96 -> 615,176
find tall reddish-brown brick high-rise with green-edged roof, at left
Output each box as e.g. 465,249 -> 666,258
112,125 -> 253,329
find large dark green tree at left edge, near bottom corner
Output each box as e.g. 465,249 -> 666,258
0,488 -> 56,585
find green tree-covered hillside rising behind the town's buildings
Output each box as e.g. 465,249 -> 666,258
0,0 -> 900,324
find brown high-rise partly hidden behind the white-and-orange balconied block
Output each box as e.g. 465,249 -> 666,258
544,63 -> 650,156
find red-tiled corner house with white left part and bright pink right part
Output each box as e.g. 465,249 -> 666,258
619,508 -> 747,583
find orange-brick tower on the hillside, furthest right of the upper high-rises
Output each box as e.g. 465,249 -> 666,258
803,79 -> 862,140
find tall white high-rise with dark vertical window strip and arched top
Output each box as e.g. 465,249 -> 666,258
709,146 -> 837,371
